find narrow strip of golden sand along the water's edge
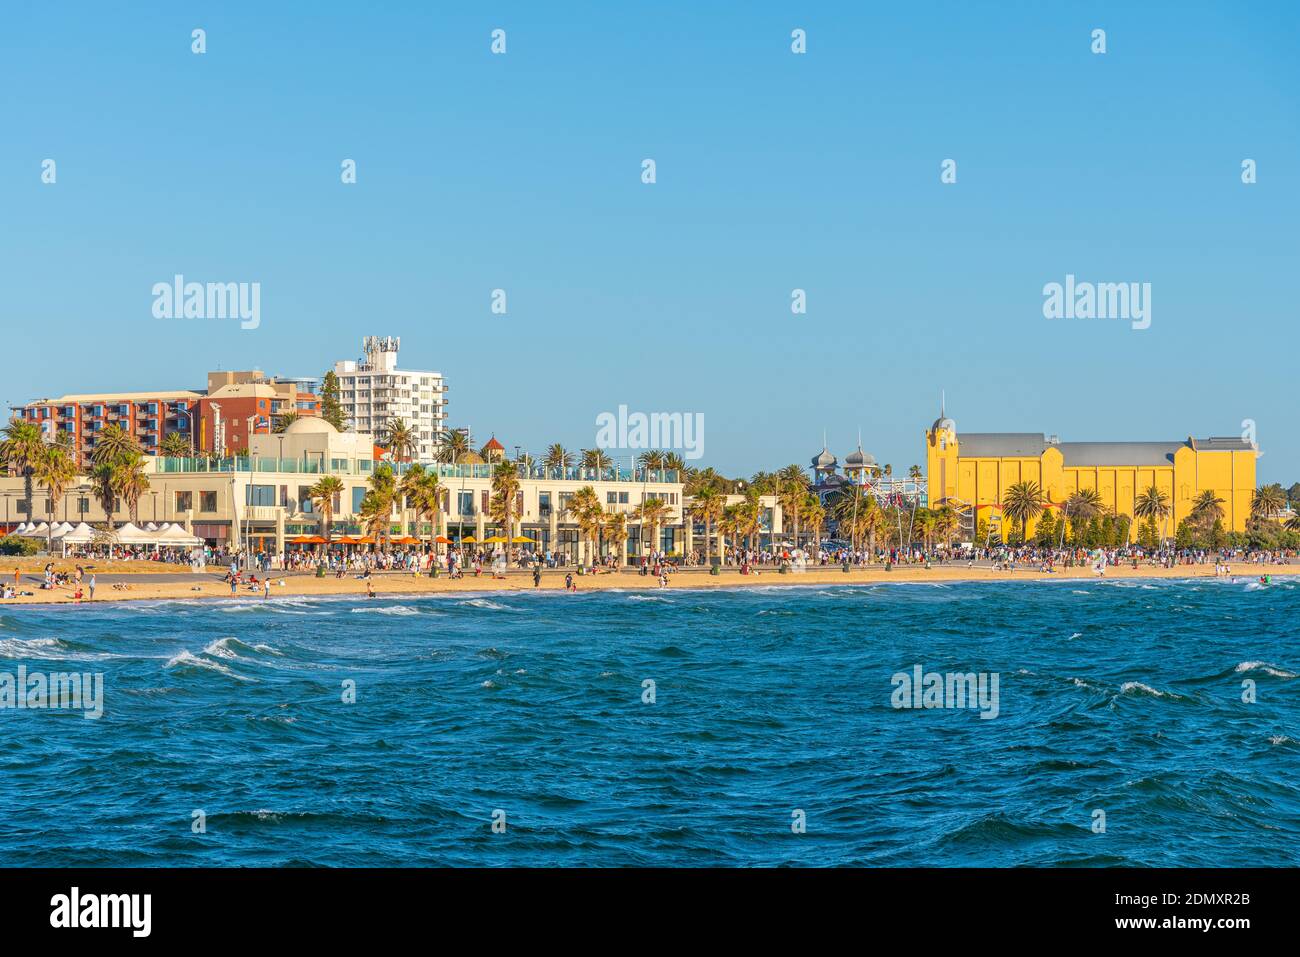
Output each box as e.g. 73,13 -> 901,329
0,563 -> 1300,610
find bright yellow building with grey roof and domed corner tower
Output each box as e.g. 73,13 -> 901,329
926,408 -> 1258,538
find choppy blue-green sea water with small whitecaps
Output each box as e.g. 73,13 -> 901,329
0,579 -> 1300,866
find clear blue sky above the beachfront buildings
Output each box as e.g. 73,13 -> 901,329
0,1 -> 1300,485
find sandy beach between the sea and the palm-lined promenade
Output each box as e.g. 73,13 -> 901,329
0,559 -> 1300,607
